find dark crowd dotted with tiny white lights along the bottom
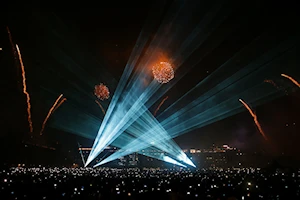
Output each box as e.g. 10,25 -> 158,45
0,167 -> 300,200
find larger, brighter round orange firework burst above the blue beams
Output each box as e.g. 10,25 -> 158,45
152,62 -> 174,83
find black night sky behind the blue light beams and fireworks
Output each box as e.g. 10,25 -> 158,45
0,0 -> 300,162
